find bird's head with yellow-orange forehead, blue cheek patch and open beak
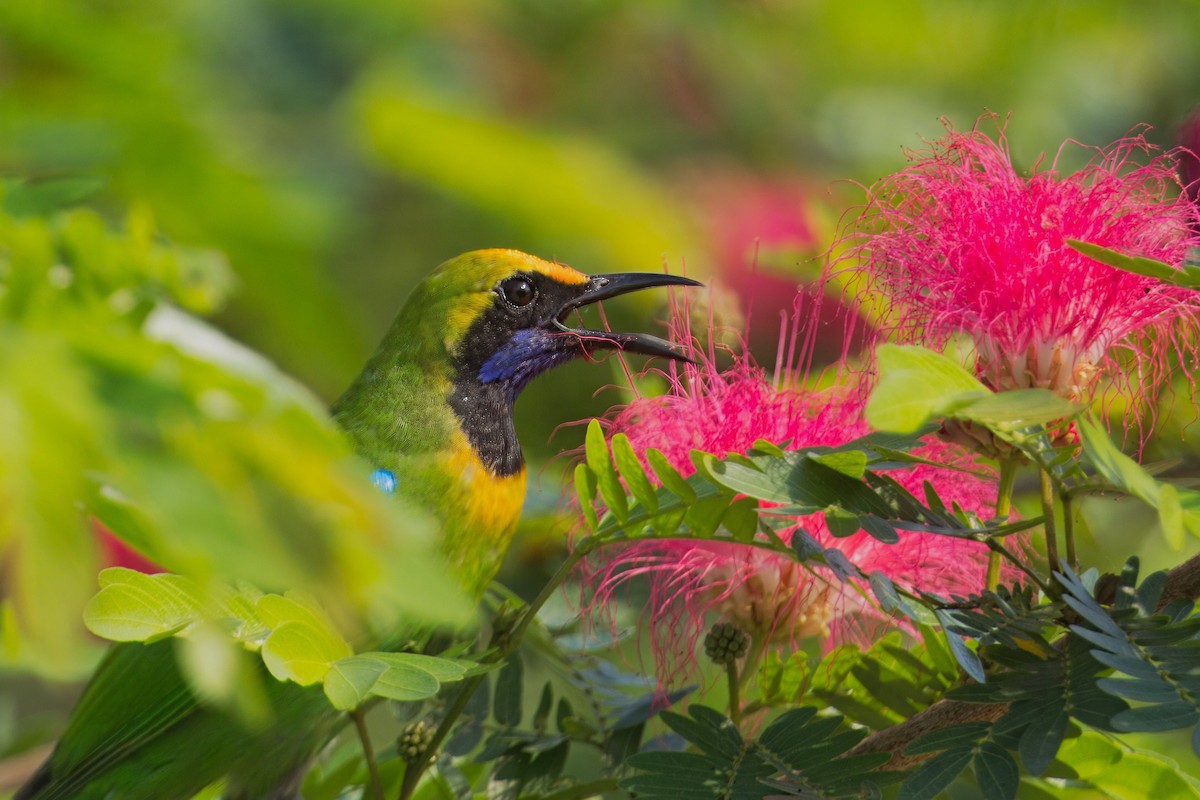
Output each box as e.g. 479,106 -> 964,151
406,249 -> 700,399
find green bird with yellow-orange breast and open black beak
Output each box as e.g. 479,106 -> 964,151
14,249 -> 700,800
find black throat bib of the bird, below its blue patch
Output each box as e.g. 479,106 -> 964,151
446,372 -> 524,477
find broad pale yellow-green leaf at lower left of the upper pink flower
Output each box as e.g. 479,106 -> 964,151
866,344 -> 991,433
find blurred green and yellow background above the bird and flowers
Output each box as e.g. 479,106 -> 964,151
9,0 -> 1200,472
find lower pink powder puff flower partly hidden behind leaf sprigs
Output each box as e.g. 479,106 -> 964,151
583,295 -> 1016,684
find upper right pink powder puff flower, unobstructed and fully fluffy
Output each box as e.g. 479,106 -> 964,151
844,117 -> 1200,422
